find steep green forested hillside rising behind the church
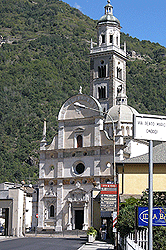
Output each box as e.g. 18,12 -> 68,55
0,0 -> 166,182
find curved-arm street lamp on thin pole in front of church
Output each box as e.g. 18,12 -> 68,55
74,102 -> 117,184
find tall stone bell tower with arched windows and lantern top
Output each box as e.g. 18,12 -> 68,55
90,0 -> 127,112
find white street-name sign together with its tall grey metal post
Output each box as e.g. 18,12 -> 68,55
133,114 -> 166,250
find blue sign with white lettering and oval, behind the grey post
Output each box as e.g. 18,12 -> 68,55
138,207 -> 166,227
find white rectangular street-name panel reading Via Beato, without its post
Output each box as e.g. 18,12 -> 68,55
133,114 -> 166,141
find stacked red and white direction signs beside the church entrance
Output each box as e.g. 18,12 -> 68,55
100,184 -> 118,217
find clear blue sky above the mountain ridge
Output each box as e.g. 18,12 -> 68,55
63,0 -> 166,47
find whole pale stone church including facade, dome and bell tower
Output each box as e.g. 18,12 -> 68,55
38,0 -> 148,231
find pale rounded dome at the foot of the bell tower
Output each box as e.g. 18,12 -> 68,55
106,104 -> 139,122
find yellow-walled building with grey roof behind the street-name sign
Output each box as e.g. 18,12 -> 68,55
117,142 -> 166,200
